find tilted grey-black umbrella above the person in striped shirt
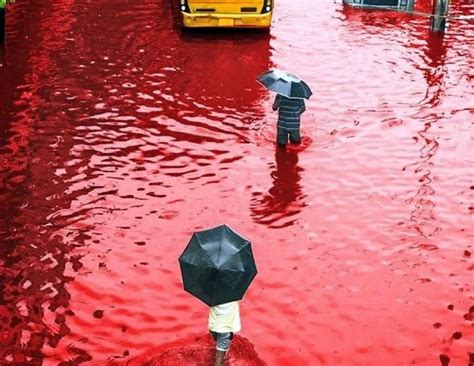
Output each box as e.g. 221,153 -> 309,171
258,70 -> 313,99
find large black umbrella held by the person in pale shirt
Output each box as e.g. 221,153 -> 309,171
179,225 -> 257,306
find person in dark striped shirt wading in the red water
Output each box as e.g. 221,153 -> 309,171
273,94 -> 306,147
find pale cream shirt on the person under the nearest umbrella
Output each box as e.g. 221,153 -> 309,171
209,301 -> 240,333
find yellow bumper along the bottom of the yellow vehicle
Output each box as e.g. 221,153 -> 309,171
181,12 -> 272,28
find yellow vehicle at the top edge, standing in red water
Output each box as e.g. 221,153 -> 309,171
179,0 -> 273,28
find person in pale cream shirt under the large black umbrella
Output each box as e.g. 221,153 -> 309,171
208,301 -> 240,366
